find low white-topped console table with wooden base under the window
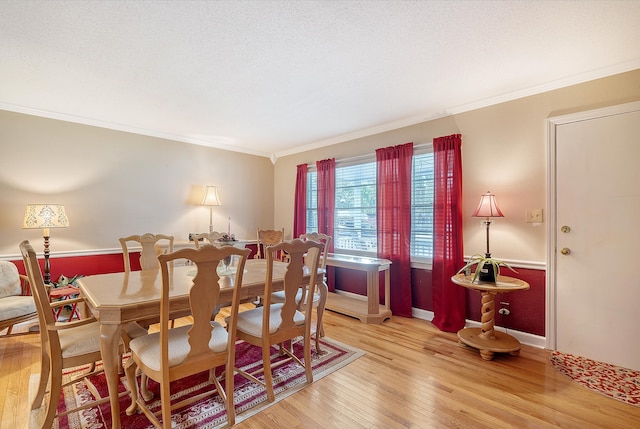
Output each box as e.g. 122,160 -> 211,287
325,253 -> 391,323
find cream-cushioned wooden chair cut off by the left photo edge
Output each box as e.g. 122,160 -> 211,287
0,261 -> 38,335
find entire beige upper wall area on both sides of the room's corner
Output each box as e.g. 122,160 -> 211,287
0,70 -> 640,265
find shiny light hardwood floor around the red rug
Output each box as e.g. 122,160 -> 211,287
0,311 -> 640,429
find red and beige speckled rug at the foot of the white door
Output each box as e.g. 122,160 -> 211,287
550,351 -> 640,407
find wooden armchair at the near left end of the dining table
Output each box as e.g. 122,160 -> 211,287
20,240 -> 127,429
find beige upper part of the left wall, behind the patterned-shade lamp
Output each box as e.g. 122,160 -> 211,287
0,111 -> 274,258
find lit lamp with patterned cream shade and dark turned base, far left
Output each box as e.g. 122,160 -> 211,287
22,204 -> 69,284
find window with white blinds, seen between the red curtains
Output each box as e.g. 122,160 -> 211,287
307,147 -> 433,262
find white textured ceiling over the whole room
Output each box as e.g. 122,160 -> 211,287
0,0 -> 640,160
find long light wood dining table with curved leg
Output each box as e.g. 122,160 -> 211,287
78,259 -> 323,429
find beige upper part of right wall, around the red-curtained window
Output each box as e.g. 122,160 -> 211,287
275,70 -> 640,265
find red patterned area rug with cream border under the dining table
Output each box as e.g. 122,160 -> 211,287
45,338 -> 364,429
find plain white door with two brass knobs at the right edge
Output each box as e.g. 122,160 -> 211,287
548,103 -> 640,370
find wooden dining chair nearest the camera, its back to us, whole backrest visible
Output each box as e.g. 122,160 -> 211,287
125,242 -> 251,428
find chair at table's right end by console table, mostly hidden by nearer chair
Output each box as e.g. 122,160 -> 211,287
271,232 -> 331,353
